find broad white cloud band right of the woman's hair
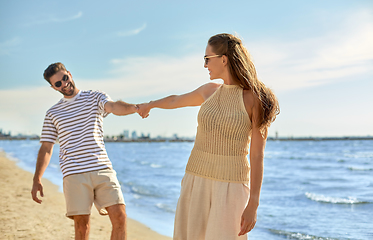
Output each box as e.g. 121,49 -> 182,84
250,10 -> 373,91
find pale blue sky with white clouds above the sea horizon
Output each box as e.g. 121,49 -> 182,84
0,0 -> 373,137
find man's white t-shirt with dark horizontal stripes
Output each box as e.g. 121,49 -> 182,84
40,91 -> 112,177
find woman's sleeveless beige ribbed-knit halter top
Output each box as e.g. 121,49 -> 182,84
185,84 -> 251,183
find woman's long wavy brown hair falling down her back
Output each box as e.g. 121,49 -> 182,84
208,33 -> 280,137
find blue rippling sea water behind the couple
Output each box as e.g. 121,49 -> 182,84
0,140 -> 373,240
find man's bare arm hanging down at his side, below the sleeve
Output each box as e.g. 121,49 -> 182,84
31,142 -> 54,203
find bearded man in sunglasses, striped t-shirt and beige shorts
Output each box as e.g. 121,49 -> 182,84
31,63 -> 137,239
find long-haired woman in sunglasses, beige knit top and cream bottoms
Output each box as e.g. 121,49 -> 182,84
138,34 -> 279,240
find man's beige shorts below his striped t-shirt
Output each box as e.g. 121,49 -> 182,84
63,169 -> 125,218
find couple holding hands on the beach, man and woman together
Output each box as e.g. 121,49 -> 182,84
31,33 -> 279,240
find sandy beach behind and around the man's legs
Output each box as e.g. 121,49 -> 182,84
0,152 -> 171,240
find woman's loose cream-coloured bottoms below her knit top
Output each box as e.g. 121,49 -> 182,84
173,173 -> 250,240
